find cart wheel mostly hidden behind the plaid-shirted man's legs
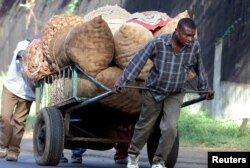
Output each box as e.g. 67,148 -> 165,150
147,128 -> 179,168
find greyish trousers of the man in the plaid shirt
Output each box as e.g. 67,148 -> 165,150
128,91 -> 184,162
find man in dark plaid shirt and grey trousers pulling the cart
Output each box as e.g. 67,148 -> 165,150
113,18 -> 211,168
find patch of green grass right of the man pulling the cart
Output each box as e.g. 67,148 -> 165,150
179,108 -> 250,150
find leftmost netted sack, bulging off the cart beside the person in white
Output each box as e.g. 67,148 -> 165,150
22,39 -> 53,80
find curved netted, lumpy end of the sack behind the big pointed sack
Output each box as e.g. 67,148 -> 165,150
42,14 -> 83,70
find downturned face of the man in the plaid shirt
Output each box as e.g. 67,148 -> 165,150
176,26 -> 195,46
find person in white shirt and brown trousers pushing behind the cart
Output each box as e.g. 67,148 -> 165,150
0,40 -> 35,161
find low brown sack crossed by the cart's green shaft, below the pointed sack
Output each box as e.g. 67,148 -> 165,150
96,67 -> 141,114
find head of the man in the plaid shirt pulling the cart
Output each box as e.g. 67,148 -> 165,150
175,18 -> 196,46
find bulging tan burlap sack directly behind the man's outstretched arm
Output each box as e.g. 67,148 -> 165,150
114,23 -> 153,80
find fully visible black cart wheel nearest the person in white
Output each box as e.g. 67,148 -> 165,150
33,107 -> 64,166
